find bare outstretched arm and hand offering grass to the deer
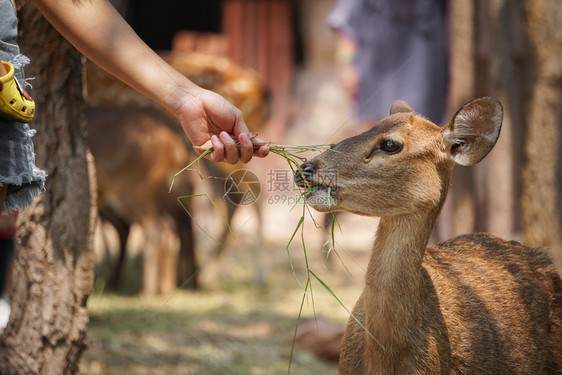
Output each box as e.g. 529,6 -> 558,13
29,0 -> 269,163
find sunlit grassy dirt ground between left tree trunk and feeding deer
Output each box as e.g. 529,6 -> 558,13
81,234 -> 364,375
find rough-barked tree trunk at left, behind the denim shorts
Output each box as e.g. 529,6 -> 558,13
0,2 -> 95,374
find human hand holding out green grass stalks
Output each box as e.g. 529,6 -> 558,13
175,88 -> 269,164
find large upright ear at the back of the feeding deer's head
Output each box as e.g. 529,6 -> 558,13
443,97 -> 503,165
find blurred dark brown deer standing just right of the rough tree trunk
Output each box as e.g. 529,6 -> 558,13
86,107 -> 197,294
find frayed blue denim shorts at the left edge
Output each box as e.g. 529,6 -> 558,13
0,0 -> 47,212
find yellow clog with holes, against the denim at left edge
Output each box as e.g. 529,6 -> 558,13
0,61 -> 35,122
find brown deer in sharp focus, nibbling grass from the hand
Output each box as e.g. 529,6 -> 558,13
295,97 -> 562,375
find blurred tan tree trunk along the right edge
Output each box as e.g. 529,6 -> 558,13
522,0 -> 562,262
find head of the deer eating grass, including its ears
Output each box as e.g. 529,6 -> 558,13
295,97 -> 503,216
